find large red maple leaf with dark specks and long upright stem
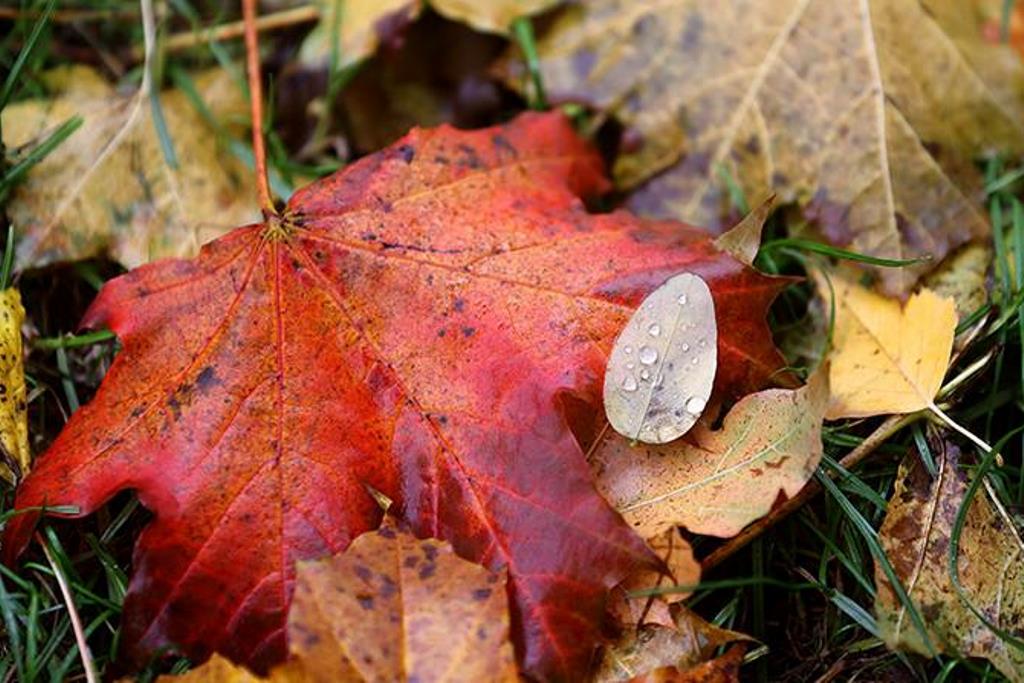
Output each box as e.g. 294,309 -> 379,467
3,114 -> 781,679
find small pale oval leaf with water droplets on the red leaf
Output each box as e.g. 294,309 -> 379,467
604,272 -> 718,443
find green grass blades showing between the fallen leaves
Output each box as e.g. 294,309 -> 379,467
0,0 -> 1024,683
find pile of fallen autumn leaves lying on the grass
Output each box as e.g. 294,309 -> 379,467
8,0 -> 1024,683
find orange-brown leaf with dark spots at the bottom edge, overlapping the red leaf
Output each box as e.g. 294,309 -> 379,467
167,518 -> 518,683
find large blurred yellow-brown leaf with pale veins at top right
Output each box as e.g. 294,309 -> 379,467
513,0 -> 1024,293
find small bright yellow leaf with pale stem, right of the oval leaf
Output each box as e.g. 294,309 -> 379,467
816,271 -> 956,420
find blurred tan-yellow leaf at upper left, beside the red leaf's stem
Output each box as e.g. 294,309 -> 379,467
3,67 -> 259,267
